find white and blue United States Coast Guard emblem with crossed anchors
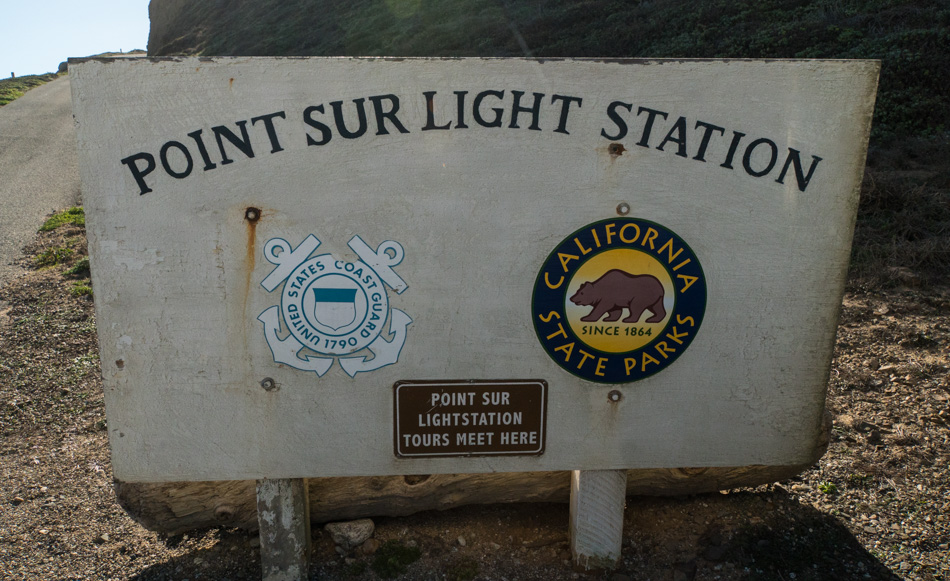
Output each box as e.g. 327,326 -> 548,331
257,234 -> 412,377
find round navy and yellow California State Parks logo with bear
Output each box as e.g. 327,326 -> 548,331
532,218 -> 706,383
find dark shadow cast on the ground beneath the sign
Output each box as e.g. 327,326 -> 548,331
133,487 -> 900,581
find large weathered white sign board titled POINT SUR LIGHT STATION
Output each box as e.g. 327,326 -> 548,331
70,58 -> 878,482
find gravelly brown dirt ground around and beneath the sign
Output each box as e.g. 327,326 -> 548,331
0,226 -> 950,581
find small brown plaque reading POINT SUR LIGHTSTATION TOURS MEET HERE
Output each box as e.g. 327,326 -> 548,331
393,379 -> 548,458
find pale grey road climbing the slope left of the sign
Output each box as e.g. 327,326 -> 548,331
0,77 -> 79,285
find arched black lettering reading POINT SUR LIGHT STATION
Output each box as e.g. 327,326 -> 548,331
119,89 -> 823,196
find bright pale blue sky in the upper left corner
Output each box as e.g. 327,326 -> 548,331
0,0 -> 149,79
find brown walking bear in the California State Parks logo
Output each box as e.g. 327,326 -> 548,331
571,269 -> 666,323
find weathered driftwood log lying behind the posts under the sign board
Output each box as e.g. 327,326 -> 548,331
115,414 -> 831,534
